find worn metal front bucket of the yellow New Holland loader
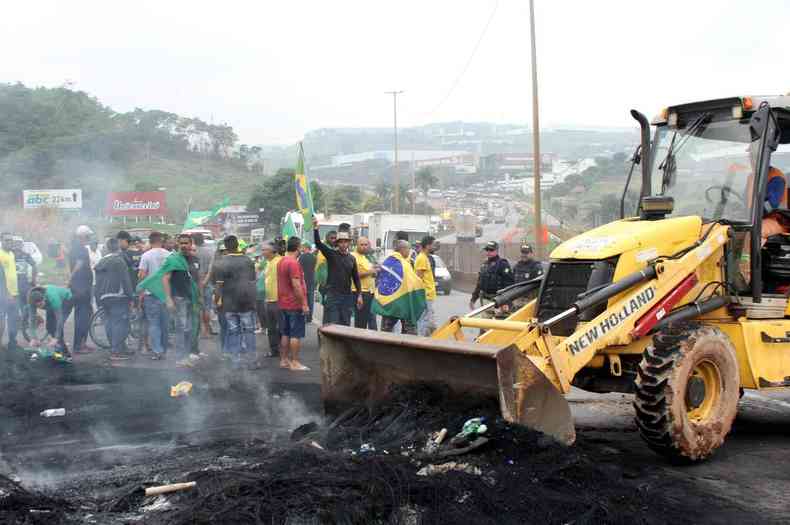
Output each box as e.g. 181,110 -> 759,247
319,325 -> 575,444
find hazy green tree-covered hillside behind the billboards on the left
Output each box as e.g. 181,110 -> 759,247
0,84 -> 262,222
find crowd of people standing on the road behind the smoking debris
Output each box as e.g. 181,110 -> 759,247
0,221 -> 542,371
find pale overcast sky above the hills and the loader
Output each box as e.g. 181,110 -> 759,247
0,0 -> 790,143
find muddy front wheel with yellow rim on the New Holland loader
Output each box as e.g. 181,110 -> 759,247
634,323 -> 740,462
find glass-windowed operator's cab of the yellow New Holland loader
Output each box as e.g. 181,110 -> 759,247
623,96 -> 790,302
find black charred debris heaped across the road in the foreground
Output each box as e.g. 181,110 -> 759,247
0,348 -> 768,525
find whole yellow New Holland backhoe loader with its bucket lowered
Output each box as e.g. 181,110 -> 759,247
320,96 -> 790,461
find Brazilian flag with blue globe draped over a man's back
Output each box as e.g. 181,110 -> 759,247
371,252 -> 427,323
